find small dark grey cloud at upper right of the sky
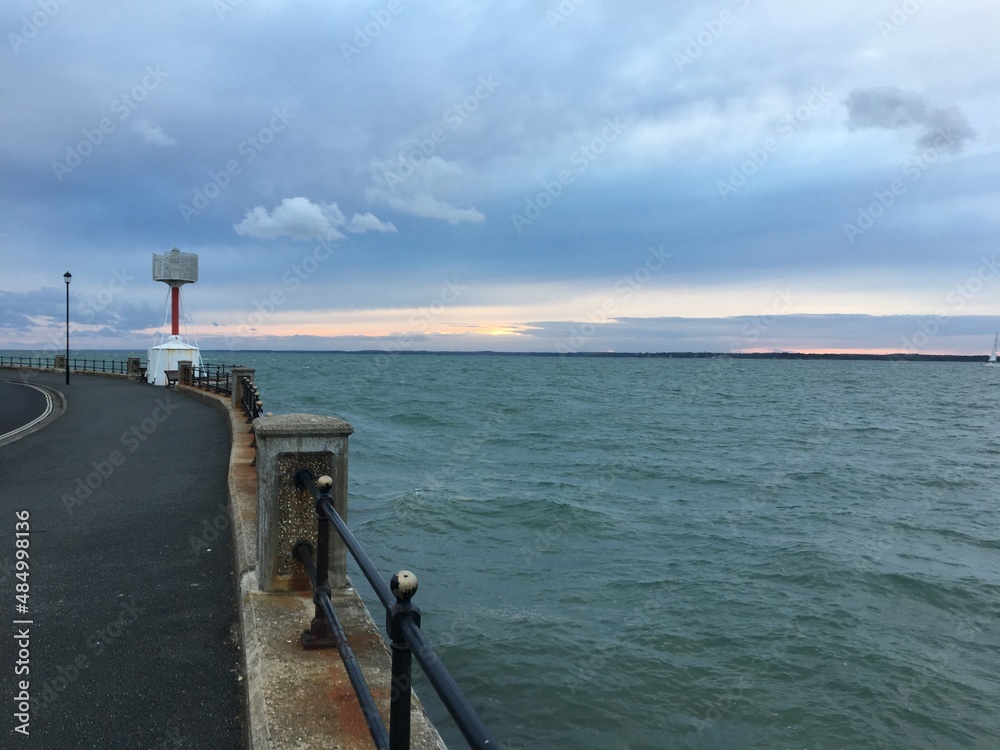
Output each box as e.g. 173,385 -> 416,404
845,86 -> 976,154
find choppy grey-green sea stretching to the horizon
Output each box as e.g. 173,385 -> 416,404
15,352 -> 1000,750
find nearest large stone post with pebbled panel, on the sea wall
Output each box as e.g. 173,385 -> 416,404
253,414 -> 354,591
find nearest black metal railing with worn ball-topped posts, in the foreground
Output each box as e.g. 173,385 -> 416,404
292,468 -> 500,750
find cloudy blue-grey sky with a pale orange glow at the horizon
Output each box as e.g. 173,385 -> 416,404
0,0 -> 1000,354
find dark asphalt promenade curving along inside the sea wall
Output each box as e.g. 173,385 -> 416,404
0,372 -> 243,750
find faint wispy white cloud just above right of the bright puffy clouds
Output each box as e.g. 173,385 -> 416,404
365,154 -> 486,224
